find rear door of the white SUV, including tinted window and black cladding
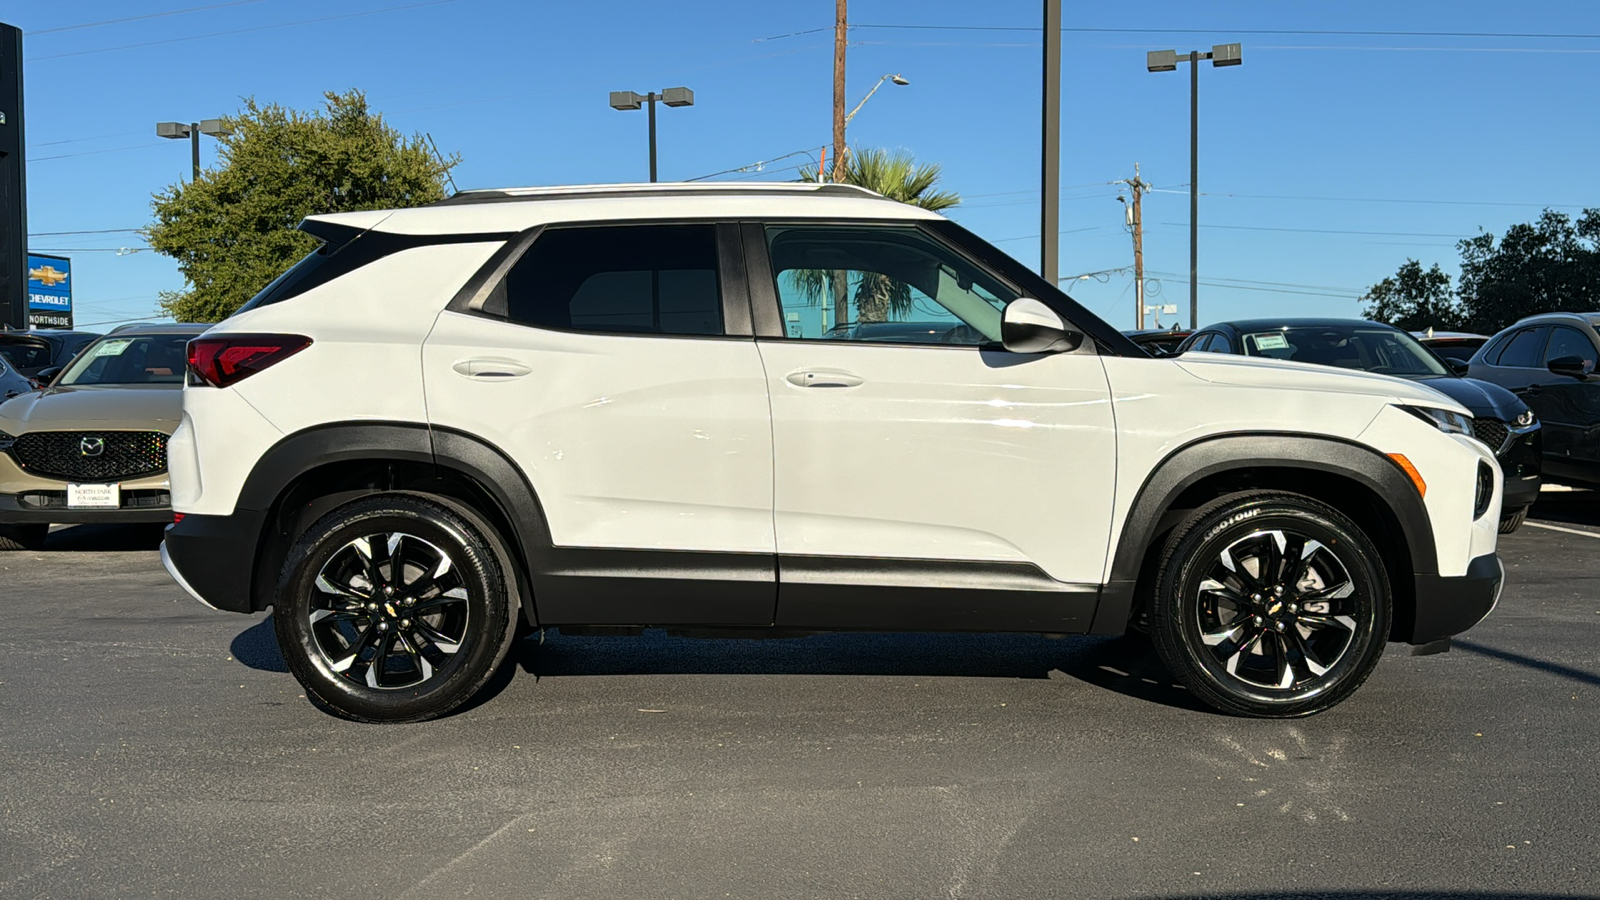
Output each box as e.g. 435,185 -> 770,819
422,223 -> 776,625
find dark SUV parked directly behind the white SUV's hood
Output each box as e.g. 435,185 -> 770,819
1178,319 -> 1542,535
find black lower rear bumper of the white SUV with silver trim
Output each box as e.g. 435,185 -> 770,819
162,511 -> 262,613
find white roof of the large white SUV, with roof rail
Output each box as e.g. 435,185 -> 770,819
302,181 -> 944,234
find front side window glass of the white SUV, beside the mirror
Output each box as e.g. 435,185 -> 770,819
766,226 -> 1018,346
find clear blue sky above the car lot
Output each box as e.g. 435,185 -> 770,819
12,0 -> 1600,328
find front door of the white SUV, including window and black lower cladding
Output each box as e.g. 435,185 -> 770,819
744,223 -> 1115,631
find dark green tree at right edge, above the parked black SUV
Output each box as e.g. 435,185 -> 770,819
1458,210 -> 1600,333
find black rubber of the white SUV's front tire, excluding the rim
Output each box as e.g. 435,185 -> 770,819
1155,496 -> 1392,717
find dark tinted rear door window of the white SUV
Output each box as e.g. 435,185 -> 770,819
504,224 -> 723,335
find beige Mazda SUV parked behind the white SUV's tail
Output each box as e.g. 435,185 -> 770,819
0,325 -> 208,549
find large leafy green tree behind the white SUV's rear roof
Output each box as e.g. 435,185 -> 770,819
144,90 -> 461,322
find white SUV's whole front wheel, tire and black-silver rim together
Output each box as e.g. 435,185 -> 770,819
1150,492 -> 1392,719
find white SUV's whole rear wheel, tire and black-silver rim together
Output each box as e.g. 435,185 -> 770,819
272,493 -> 518,722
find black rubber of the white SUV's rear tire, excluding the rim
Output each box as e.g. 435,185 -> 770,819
274,495 -> 512,721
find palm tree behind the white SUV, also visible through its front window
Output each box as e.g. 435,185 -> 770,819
789,149 -> 962,322
